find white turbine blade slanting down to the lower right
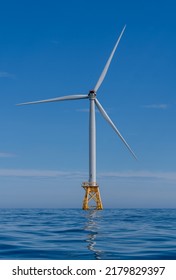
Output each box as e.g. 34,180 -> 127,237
95,99 -> 137,159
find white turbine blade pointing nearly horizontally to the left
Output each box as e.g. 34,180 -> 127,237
17,94 -> 88,106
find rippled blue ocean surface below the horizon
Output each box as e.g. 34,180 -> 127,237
0,209 -> 176,260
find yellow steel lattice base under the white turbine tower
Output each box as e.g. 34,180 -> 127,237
82,183 -> 103,210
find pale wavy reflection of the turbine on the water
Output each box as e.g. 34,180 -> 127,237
84,210 -> 103,260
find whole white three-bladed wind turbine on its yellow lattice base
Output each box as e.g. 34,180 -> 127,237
17,26 -> 136,210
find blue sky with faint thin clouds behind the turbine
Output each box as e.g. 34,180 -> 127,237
0,0 -> 176,208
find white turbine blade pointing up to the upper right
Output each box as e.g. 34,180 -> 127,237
94,25 -> 126,92
